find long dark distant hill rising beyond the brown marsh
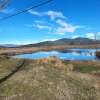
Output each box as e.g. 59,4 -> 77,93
20,37 -> 100,47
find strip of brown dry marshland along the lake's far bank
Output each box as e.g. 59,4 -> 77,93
0,44 -> 100,55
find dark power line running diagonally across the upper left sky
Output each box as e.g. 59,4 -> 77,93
0,0 -> 53,21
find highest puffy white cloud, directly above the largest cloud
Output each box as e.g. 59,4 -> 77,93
44,11 -> 66,20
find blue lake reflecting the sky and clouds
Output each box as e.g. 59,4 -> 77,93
12,49 -> 100,60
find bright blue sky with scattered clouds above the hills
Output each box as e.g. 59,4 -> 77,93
0,0 -> 100,44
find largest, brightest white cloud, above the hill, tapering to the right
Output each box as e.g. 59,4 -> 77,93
55,20 -> 84,35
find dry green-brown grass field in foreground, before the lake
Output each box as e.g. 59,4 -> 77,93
0,57 -> 100,100
